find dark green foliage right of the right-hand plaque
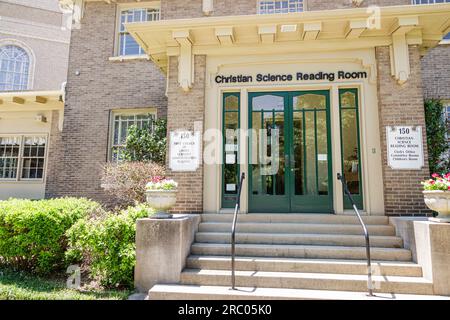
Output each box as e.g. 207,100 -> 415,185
425,99 -> 450,173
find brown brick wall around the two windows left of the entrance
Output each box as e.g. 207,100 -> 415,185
46,1 -> 167,201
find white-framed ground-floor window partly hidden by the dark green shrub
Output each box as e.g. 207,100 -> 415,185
110,109 -> 156,162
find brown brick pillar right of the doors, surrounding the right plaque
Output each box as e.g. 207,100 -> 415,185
376,46 -> 429,215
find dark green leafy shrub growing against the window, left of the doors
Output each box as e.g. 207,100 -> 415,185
123,119 -> 167,165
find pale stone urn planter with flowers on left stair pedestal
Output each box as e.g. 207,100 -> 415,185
145,177 -> 178,219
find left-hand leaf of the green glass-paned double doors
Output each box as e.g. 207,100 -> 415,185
249,93 -> 289,212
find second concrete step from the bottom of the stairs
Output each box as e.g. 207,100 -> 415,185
181,269 -> 433,295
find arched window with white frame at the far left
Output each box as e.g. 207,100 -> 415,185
0,45 -> 30,91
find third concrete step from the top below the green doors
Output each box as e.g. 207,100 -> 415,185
195,232 -> 403,248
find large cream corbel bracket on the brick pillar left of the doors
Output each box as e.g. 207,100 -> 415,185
172,30 -> 194,92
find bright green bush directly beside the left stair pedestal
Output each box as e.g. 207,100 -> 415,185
66,205 -> 150,287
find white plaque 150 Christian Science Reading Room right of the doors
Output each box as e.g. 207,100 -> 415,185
386,126 -> 423,170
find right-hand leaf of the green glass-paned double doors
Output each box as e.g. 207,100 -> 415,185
290,91 -> 333,213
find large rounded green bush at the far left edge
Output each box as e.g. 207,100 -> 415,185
0,198 -> 101,274
